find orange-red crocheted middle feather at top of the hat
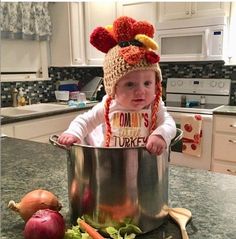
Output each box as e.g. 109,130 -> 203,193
113,16 -> 136,42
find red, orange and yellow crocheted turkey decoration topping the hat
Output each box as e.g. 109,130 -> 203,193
90,16 -> 160,65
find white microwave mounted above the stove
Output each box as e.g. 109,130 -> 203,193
157,17 -> 227,62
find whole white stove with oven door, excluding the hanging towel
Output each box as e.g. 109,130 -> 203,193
166,78 -> 231,170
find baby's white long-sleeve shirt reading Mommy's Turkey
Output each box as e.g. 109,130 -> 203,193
65,96 -> 176,147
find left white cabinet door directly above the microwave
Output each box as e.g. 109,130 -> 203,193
159,2 -> 191,22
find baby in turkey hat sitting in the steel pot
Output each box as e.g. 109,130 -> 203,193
58,16 -> 176,155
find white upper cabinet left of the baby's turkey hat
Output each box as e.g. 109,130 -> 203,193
49,1 -> 117,66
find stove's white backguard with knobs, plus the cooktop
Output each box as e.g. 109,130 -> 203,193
166,78 -> 231,114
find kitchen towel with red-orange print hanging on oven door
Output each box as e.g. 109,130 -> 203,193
181,114 -> 202,157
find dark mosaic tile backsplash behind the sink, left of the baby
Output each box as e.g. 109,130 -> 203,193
1,67 -> 103,107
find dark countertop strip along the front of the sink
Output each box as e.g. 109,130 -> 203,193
1,103 -> 97,124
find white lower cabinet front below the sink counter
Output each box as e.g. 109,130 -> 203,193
1,110 -> 86,143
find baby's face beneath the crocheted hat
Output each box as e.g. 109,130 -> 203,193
115,70 -> 156,110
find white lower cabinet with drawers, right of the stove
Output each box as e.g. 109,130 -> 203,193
211,115 -> 236,175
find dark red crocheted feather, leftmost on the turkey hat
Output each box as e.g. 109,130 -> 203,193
90,27 -> 117,53
